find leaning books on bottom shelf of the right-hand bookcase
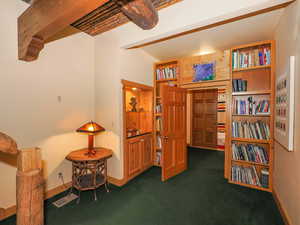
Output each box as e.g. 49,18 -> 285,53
231,165 -> 262,187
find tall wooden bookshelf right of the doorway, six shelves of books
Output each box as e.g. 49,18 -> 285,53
228,41 -> 275,192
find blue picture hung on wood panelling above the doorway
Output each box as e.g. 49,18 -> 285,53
193,62 -> 216,82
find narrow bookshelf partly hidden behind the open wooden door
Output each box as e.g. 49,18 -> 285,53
153,60 -> 179,167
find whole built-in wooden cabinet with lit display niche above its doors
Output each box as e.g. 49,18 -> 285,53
122,80 -> 154,184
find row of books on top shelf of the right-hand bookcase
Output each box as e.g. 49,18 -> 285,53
232,47 -> 271,69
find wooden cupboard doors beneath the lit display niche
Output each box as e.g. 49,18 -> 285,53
125,134 -> 153,179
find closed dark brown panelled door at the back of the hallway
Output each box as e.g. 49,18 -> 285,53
191,89 -> 218,148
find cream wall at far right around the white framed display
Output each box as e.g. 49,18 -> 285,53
274,1 -> 300,225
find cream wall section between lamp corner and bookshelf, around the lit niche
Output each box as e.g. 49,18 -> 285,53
95,31 -> 155,179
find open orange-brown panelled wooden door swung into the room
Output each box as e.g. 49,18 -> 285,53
161,86 -> 187,181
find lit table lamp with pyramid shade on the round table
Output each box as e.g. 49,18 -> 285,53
76,121 -> 105,156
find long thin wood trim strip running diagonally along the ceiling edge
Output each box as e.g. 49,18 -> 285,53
126,0 -> 295,49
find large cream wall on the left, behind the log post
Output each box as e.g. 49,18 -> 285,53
0,0 -> 94,208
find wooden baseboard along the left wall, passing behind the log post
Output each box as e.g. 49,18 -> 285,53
0,182 -> 72,221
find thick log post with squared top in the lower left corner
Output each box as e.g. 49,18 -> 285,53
17,148 -> 44,225
